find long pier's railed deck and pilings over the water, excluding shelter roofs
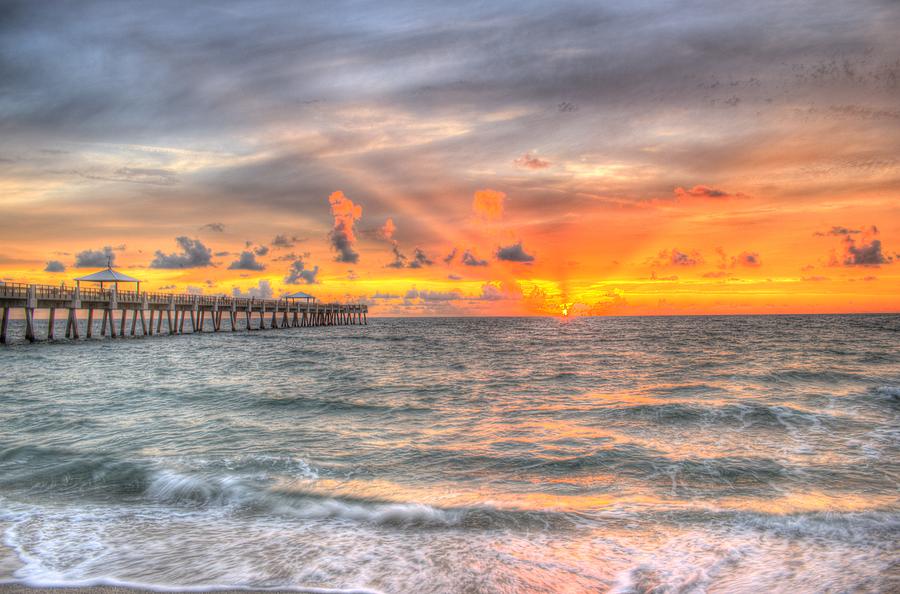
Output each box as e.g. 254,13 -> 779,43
0,283 -> 369,344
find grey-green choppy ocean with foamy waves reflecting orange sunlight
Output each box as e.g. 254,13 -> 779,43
0,315 -> 900,594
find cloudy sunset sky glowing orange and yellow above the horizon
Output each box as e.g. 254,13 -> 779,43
0,0 -> 900,316
